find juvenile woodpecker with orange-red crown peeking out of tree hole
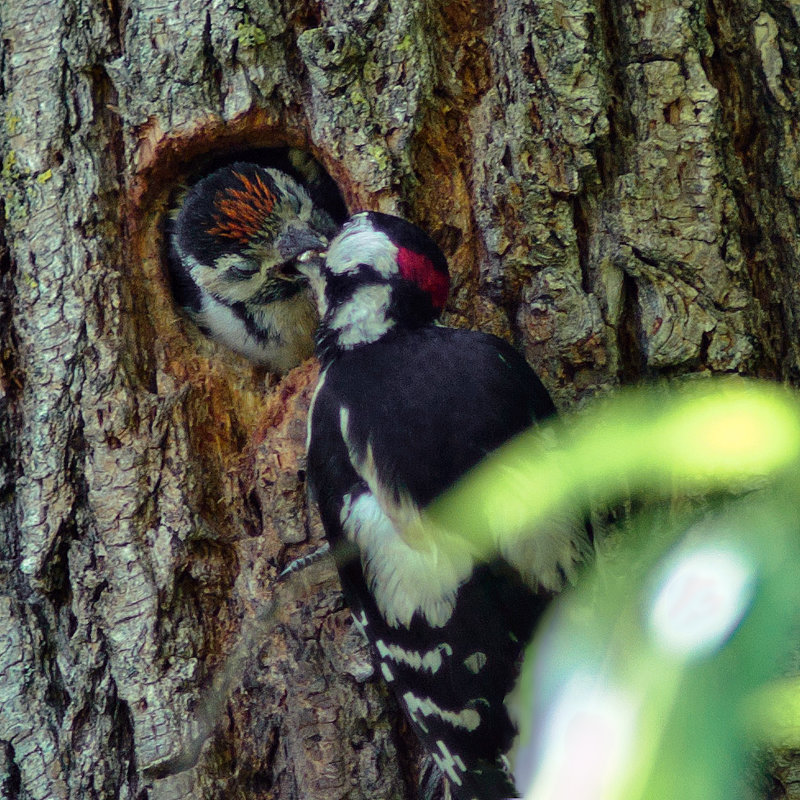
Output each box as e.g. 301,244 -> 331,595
167,162 -> 337,373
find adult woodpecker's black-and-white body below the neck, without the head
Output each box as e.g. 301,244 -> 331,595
308,328 -> 580,800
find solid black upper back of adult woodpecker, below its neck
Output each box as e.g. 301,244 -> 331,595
309,326 -> 555,507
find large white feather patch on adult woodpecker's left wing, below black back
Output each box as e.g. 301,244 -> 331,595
341,492 -> 473,628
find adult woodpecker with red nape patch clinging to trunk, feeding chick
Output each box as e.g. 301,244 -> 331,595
298,212 -> 589,800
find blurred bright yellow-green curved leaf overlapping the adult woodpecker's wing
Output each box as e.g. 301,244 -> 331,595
426,379 -> 800,548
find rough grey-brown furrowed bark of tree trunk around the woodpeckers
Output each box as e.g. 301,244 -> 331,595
0,0 -> 800,800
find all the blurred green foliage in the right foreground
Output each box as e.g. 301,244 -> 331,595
428,380 -> 800,800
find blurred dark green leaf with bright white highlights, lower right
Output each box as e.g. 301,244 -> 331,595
521,487 -> 800,800
